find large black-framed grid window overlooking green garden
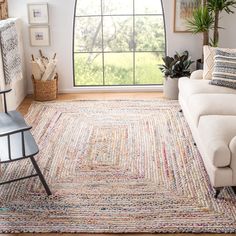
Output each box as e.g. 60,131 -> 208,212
74,0 -> 165,86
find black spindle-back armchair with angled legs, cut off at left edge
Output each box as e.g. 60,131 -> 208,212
0,89 -> 52,196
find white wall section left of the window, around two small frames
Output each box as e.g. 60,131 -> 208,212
8,0 -> 74,92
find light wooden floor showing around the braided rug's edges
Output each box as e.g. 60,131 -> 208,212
14,92 -> 232,236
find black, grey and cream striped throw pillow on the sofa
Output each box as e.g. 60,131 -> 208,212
210,49 -> 236,89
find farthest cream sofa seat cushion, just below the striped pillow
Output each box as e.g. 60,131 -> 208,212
179,77 -> 236,102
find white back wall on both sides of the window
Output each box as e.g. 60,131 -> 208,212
8,0 -> 236,92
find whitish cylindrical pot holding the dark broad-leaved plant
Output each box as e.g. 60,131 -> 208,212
163,77 -> 179,100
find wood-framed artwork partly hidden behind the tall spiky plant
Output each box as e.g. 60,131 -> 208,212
174,0 -> 201,33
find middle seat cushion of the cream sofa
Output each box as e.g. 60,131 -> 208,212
187,93 -> 236,126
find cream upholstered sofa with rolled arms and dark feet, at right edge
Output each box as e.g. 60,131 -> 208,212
179,71 -> 236,197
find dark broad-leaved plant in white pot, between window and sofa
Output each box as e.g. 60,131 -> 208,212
159,51 -> 193,100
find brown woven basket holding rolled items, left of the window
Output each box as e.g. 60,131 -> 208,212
32,75 -> 58,102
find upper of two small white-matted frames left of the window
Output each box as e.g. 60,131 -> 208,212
28,3 -> 49,25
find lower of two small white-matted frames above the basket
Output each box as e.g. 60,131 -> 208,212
29,26 -> 50,47
